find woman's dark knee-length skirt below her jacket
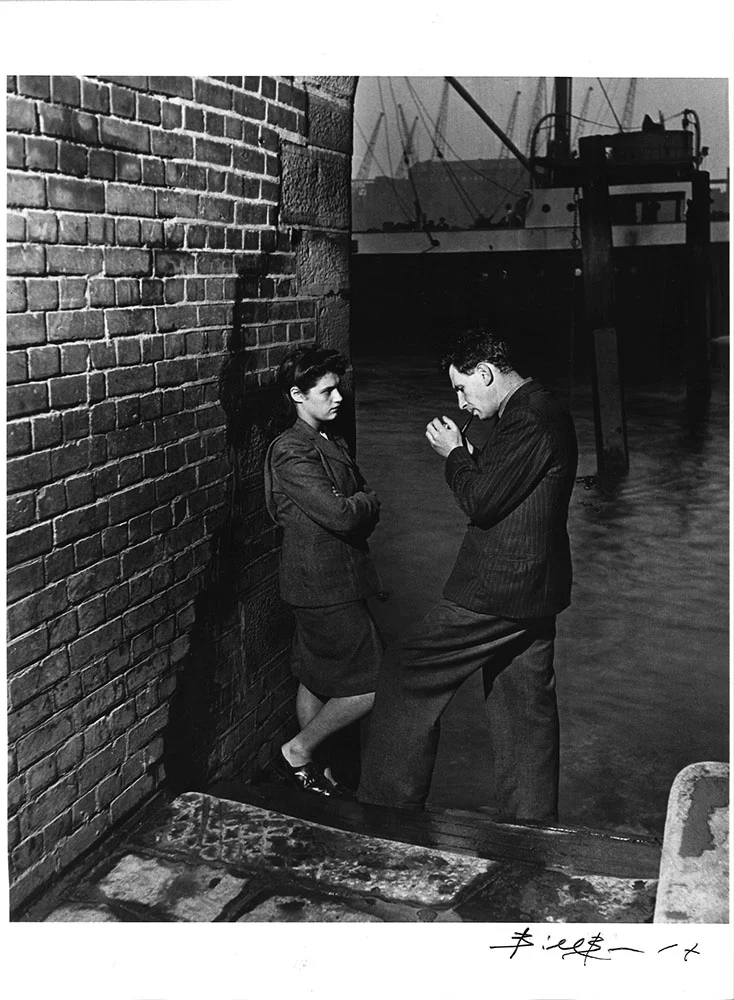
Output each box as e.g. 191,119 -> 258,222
291,601 -> 384,698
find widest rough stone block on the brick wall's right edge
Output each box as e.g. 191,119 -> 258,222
281,142 -> 351,232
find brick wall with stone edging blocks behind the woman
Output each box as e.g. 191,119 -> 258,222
7,76 -> 355,906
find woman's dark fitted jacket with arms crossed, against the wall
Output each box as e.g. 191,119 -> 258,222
265,419 -> 380,608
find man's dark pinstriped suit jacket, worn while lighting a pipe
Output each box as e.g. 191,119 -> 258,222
443,380 -> 578,618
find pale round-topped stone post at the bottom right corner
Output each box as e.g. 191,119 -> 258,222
654,761 -> 729,924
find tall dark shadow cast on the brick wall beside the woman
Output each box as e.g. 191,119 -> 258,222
164,273 -> 290,793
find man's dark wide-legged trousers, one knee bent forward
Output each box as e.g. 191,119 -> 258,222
357,599 -> 559,822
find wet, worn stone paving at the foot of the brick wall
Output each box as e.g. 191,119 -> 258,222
32,792 -> 657,923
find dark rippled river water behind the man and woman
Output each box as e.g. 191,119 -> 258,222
354,357 -> 729,836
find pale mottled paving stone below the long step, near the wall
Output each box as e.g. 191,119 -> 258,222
97,854 -> 247,922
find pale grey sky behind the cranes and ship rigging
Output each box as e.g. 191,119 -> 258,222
353,76 -> 729,180
